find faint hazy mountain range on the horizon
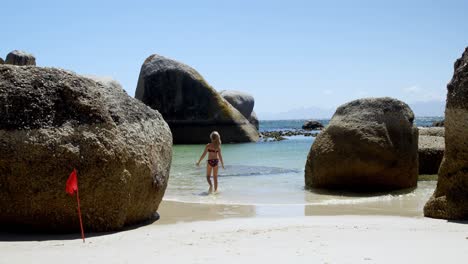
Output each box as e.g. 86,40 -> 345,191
257,101 -> 445,120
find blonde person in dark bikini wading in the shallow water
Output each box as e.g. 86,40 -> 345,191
197,131 -> 224,193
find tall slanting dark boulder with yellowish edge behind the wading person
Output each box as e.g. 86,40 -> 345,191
135,54 -> 259,144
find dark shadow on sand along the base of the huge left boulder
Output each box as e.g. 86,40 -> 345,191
0,213 -> 160,242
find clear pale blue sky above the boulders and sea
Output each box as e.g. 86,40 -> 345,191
0,0 -> 468,116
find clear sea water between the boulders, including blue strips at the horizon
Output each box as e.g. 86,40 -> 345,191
164,117 -> 442,214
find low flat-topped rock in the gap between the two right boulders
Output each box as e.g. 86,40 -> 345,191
418,134 -> 445,174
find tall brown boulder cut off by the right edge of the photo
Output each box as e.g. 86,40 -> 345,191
424,48 -> 468,220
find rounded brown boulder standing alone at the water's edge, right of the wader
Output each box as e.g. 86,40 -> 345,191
305,97 -> 418,192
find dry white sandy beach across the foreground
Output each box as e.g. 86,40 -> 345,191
0,216 -> 468,264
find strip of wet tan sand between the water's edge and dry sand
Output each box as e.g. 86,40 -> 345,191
155,196 -> 424,224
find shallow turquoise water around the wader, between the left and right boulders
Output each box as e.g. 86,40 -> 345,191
165,138 -> 312,204
